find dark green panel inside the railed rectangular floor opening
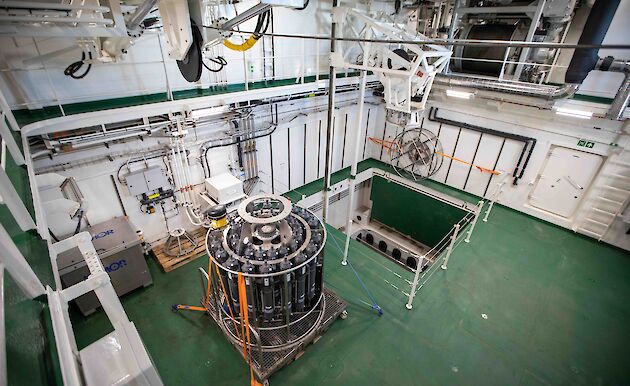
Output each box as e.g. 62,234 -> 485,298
370,176 -> 467,248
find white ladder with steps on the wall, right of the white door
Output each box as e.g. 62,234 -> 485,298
572,149 -> 630,241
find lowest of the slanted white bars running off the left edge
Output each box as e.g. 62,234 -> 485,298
0,225 -> 46,299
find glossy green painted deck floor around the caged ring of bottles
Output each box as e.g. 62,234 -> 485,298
0,155 -> 630,385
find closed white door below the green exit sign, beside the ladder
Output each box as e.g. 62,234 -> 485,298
529,147 -> 602,218
